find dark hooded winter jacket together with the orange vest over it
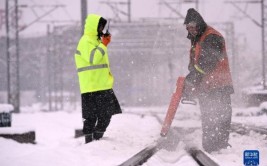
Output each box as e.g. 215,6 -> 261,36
184,9 -> 234,94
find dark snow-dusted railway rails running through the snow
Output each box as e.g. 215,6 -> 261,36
120,113 -> 267,166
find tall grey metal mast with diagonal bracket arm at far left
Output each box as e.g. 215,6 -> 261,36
5,0 -> 64,113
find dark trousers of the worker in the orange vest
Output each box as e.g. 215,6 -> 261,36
199,91 -> 232,153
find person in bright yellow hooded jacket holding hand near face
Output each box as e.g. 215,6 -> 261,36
75,14 -> 121,143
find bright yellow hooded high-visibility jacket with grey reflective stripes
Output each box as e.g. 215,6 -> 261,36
74,14 -> 114,93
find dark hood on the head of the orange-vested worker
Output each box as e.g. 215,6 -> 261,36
184,8 -> 207,41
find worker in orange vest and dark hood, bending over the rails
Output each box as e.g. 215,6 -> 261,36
183,8 -> 234,153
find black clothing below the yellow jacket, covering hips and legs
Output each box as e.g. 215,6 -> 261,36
82,89 -> 121,139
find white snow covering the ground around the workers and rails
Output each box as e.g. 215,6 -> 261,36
0,105 -> 267,166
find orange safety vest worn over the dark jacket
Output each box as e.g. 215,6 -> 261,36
193,26 -> 233,92
